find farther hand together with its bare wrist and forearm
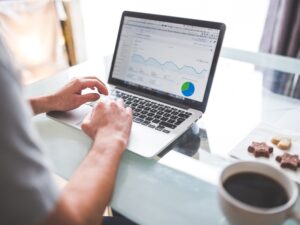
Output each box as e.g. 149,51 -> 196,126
30,77 -> 108,114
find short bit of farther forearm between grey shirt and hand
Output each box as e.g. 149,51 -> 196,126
29,95 -> 53,115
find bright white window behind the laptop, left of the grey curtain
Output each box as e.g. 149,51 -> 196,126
81,0 -> 269,58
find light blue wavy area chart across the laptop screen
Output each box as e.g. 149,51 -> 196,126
131,54 -> 207,75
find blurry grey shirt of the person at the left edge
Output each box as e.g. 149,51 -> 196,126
0,37 -> 59,225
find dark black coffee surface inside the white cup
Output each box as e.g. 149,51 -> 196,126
223,172 -> 288,208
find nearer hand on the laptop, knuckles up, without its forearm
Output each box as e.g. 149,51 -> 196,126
81,100 -> 132,150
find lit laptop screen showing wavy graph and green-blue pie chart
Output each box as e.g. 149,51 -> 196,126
111,11 -> 224,111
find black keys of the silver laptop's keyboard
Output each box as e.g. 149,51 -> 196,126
112,90 -> 192,133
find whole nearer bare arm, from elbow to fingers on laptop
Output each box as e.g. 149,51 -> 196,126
44,101 -> 132,225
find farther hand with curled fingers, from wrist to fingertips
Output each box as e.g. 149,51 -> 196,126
51,77 -> 108,111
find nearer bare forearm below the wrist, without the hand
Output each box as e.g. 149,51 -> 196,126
66,141 -> 121,225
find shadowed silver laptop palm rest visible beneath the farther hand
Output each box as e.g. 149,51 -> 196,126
47,105 -> 92,126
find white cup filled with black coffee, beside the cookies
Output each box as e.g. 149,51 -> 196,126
218,161 -> 300,225
